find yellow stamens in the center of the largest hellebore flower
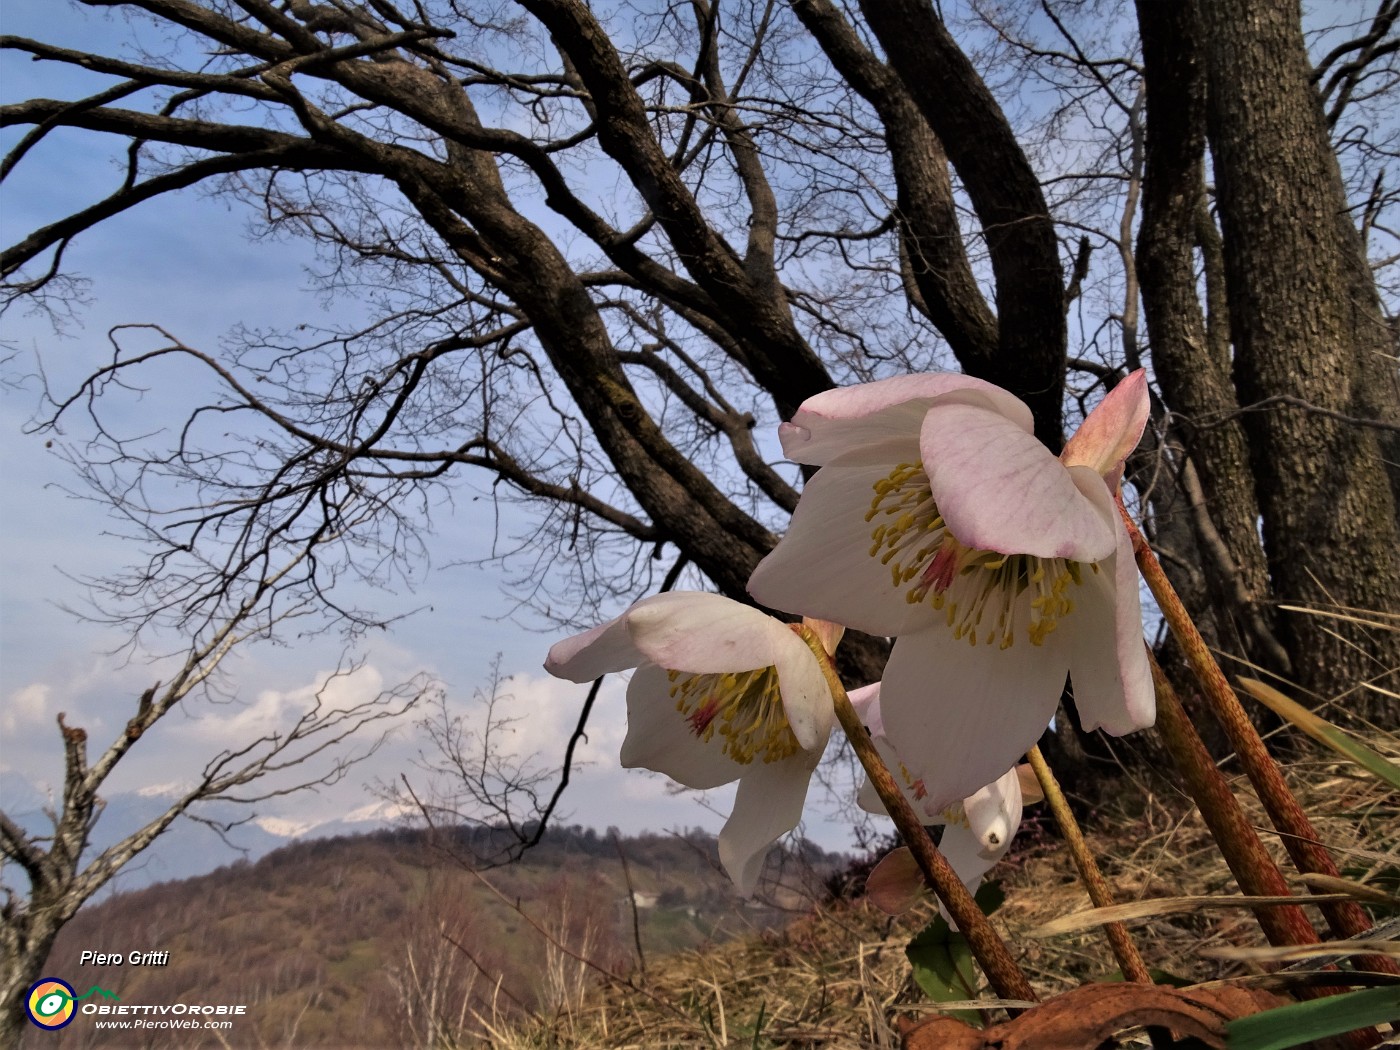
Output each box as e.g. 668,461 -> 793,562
865,463 -> 1099,650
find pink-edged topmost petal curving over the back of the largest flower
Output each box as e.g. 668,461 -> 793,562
778,372 -> 1033,466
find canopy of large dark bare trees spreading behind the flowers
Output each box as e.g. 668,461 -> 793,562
0,0 -> 1400,828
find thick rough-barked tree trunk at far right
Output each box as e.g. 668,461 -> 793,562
1201,0 -> 1400,724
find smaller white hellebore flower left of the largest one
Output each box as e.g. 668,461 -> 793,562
545,591 -> 840,896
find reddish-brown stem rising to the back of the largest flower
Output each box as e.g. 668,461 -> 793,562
1119,503 -> 1400,974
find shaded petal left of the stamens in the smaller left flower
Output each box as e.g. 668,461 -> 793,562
622,664 -> 748,788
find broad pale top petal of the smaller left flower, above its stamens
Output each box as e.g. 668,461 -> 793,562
623,591 -> 805,673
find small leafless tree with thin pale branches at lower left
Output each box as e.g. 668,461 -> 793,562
0,537 -> 434,1044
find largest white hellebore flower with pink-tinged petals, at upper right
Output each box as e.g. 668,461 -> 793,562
749,371 -> 1155,811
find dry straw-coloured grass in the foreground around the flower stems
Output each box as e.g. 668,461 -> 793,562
483,742 -> 1400,1050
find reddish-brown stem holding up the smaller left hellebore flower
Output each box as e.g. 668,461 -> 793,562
794,626 -> 1039,1002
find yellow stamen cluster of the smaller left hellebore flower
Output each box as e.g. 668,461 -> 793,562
666,666 -> 802,766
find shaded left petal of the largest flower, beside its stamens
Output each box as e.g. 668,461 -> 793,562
749,455 -> 932,634
